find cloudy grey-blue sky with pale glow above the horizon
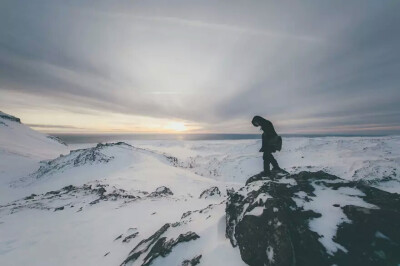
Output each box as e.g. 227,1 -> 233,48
0,0 -> 400,134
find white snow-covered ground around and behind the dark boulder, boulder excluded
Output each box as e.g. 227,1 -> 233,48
0,115 -> 400,265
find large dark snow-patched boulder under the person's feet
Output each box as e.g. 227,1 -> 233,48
226,172 -> 400,266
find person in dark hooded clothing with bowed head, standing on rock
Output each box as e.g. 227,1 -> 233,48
251,115 -> 282,175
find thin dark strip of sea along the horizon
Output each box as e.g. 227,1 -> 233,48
52,133 -> 386,144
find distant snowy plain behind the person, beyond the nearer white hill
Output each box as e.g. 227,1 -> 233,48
132,136 -> 400,193
